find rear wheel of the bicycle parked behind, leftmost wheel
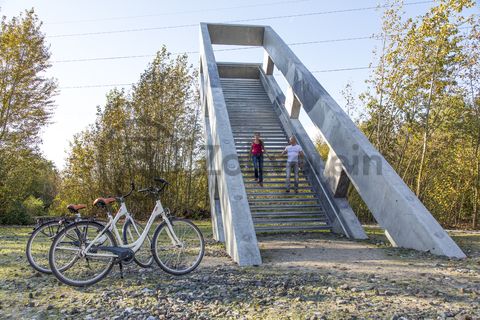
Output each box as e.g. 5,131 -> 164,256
25,220 -> 63,274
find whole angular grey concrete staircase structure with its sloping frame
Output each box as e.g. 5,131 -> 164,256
200,23 -> 465,265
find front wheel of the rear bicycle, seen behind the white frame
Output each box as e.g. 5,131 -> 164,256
122,220 -> 153,268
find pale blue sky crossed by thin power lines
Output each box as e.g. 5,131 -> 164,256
0,0 -> 478,168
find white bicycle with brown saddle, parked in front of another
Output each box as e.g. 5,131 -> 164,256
49,179 -> 205,287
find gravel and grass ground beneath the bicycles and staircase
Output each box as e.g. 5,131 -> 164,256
0,222 -> 480,320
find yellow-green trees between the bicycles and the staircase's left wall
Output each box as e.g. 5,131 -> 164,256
55,47 -> 208,217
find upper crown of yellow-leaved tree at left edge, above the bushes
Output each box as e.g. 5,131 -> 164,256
0,10 -> 57,147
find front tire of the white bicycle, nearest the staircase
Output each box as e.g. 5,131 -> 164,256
152,218 -> 205,276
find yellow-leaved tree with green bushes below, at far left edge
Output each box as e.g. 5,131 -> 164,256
0,10 -> 58,224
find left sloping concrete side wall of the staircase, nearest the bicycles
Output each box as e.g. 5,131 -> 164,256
200,24 -> 262,266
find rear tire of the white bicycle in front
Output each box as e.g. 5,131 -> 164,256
49,220 -> 117,287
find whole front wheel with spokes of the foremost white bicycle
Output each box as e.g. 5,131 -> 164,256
152,219 -> 205,275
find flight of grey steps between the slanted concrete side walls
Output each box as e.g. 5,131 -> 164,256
221,78 -> 331,233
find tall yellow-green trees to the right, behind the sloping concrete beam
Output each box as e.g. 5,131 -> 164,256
350,0 -> 480,228
